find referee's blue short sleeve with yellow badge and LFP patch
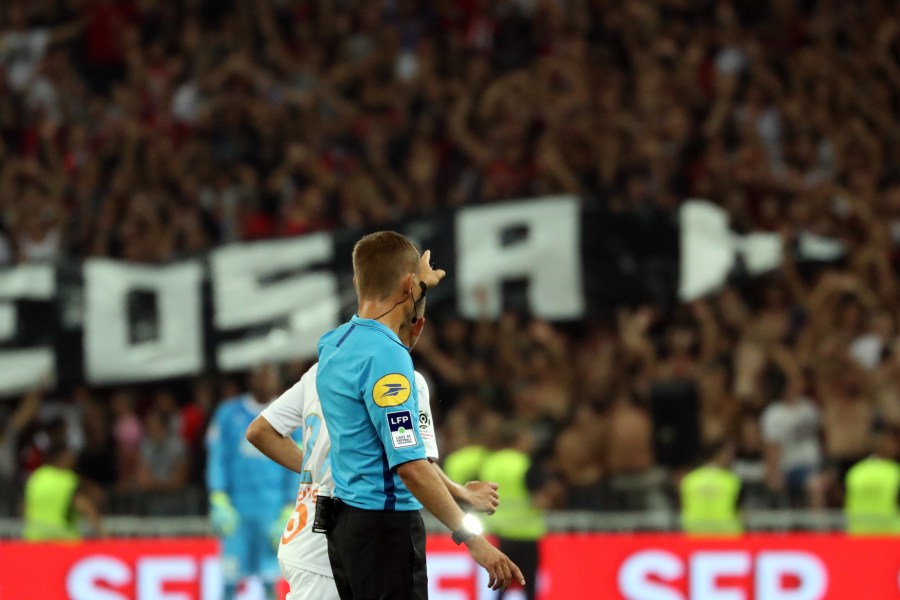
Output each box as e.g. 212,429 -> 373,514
364,346 -> 425,469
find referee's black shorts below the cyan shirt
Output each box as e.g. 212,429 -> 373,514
328,501 -> 428,600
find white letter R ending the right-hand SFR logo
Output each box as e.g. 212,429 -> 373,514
754,551 -> 828,600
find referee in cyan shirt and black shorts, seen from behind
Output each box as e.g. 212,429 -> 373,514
316,231 -> 525,600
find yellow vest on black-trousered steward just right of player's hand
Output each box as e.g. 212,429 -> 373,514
478,450 -> 547,541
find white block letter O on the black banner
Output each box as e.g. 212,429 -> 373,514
84,259 -> 203,384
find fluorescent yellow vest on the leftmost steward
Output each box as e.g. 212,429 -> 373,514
24,465 -> 80,542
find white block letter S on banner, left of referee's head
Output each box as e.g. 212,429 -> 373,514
210,233 -> 340,371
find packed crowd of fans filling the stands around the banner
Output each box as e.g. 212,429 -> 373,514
0,0 -> 900,509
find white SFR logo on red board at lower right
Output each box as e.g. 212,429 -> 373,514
617,550 -> 828,600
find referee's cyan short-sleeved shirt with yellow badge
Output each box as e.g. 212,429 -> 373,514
316,316 -> 425,510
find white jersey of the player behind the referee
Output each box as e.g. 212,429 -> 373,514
262,363 -> 438,577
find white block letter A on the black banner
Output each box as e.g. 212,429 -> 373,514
458,196 -> 584,319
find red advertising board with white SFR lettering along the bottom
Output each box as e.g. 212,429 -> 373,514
0,534 -> 900,600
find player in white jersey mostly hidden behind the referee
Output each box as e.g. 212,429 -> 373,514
247,302 -> 499,600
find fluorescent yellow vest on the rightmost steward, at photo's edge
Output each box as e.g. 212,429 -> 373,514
844,457 -> 900,535
